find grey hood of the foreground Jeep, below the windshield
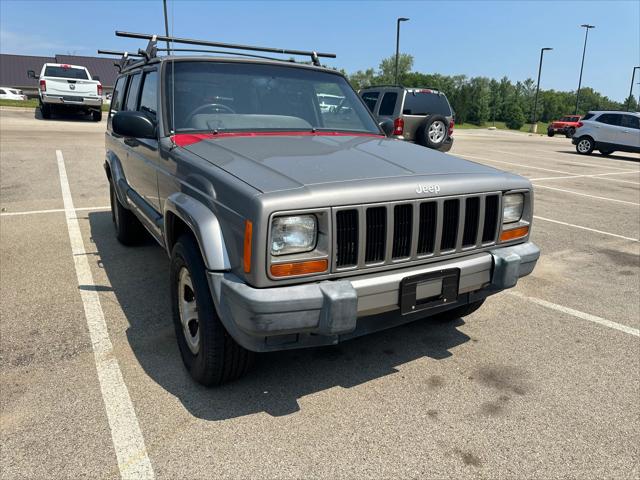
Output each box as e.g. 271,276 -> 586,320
183,135 -> 504,193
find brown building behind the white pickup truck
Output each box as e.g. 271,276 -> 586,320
0,53 -> 118,96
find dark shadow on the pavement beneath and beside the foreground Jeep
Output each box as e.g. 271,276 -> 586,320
89,212 -> 469,420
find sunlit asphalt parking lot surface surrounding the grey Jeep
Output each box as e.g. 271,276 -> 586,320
0,110 -> 640,479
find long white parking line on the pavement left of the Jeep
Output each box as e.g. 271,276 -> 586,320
56,150 -> 154,479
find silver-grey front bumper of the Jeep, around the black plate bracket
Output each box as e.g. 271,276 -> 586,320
208,242 -> 540,351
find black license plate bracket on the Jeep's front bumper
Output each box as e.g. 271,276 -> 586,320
400,268 -> 460,315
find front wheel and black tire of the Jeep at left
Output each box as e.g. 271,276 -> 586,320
170,235 -> 253,386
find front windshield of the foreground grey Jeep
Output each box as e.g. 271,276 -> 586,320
165,61 -> 380,134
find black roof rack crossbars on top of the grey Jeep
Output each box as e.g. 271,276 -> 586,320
110,30 -> 336,68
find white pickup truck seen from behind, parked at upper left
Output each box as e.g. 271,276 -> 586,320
27,63 -> 102,122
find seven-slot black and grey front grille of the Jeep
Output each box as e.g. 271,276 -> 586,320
334,192 -> 500,270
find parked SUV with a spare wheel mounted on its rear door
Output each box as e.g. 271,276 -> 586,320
359,86 -> 454,152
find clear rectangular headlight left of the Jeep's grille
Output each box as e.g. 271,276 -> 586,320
271,215 -> 318,255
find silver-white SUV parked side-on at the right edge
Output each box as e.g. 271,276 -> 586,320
571,111 -> 640,155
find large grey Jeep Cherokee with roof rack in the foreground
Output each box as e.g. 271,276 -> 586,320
105,32 -> 539,385
